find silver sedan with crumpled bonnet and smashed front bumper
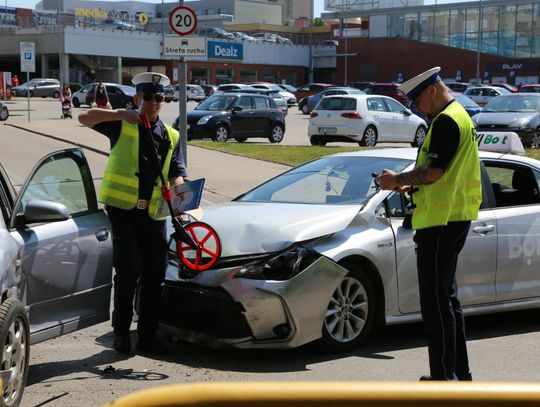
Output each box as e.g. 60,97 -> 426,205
159,139 -> 540,352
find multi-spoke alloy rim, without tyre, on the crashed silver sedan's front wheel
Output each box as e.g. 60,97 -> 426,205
324,275 -> 369,342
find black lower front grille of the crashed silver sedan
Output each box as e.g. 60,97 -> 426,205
160,282 -> 252,338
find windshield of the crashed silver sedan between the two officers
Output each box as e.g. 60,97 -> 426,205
236,156 -> 412,205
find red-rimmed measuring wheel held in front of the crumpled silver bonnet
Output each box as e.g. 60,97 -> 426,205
176,222 -> 221,271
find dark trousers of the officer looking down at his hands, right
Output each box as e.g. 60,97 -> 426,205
414,221 -> 471,380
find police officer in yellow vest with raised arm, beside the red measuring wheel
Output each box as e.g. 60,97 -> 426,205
79,72 -> 186,354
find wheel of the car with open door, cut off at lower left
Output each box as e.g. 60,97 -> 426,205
0,298 -> 30,406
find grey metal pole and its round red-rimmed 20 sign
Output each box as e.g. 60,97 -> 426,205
169,1 -> 197,166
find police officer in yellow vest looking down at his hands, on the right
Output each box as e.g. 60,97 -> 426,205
377,67 -> 482,380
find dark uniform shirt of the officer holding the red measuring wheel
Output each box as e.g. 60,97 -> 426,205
93,120 -> 187,199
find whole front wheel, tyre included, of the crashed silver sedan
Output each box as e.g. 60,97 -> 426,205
320,264 -> 376,353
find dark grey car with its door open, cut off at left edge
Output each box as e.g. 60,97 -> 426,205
0,149 -> 112,406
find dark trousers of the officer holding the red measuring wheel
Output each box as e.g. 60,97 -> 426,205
107,207 -> 167,340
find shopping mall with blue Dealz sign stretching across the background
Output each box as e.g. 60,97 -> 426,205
0,0 -> 540,85
